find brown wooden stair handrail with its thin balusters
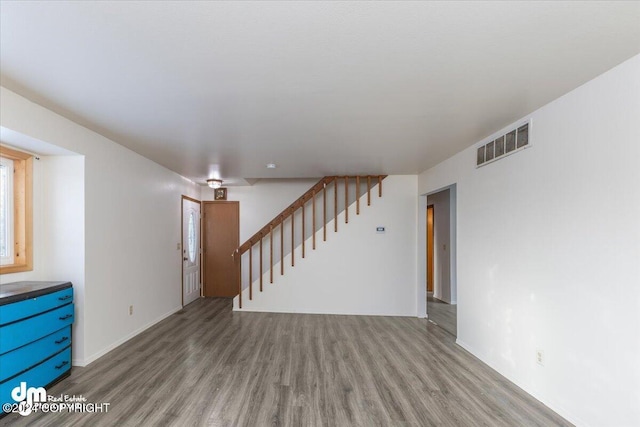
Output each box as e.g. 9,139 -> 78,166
232,175 -> 387,308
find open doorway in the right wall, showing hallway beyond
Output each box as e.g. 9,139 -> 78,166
425,185 -> 458,336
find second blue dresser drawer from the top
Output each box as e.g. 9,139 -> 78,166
0,304 -> 74,354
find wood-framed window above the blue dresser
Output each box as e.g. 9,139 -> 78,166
0,146 -> 33,274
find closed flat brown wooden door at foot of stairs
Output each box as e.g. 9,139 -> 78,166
202,202 -> 240,297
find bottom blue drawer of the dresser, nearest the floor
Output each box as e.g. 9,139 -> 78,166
0,347 -> 71,404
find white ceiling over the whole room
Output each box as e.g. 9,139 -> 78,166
0,1 -> 640,186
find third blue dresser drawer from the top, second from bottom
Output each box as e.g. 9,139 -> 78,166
0,326 -> 71,382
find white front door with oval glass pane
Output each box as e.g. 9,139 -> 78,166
182,199 -> 201,306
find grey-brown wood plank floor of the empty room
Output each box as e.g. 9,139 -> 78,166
0,299 -> 570,427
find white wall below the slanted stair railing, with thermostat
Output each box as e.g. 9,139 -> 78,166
234,175 -> 418,316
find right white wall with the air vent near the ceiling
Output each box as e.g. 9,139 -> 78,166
419,56 -> 640,426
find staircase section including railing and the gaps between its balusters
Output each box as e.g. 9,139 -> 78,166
232,175 -> 386,309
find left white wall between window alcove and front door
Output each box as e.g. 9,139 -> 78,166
0,88 -> 200,365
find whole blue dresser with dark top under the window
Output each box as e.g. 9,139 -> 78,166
0,282 -> 74,410
